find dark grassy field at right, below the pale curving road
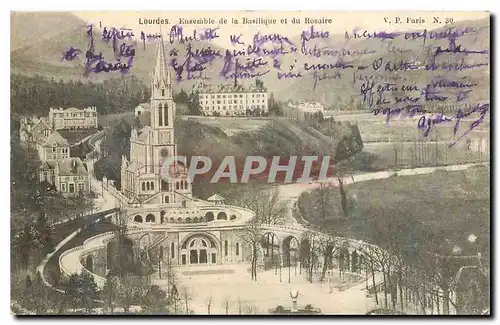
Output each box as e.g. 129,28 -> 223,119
299,167 -> 490,256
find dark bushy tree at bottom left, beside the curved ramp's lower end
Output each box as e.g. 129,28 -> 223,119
64,272 -> 98,314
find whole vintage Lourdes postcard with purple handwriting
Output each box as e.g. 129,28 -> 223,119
10,11 -> 491,316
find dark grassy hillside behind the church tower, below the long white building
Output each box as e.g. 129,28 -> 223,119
95,114 -> 363,191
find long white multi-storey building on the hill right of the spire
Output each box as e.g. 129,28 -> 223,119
199,85 -> 269,116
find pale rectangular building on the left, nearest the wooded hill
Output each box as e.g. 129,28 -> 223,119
49,107 -> 97,130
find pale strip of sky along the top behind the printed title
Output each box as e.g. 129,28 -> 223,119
75,11 -> 489,47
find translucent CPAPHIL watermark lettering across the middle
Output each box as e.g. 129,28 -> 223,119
161,156 -> 332,183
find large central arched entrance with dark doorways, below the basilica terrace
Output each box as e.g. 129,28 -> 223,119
181,234 -> 218,265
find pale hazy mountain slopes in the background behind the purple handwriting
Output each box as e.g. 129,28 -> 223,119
11,13 -> 490,109
